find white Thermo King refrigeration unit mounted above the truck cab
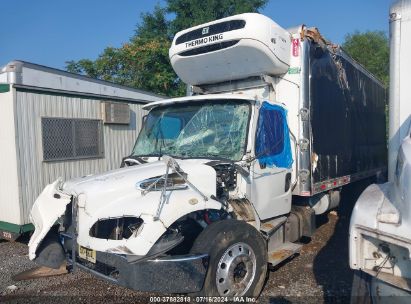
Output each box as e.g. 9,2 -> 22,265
169,13 -> 291,85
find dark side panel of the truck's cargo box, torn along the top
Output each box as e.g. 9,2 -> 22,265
310,44 -> 387,193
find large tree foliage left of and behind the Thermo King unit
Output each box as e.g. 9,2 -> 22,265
66,0 -> 268,96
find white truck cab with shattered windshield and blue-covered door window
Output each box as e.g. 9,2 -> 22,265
125,94 -> 295,220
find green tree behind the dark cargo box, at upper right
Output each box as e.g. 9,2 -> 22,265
342,31 -> 390,86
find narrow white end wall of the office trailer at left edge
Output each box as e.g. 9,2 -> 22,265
0,84 -> 21,230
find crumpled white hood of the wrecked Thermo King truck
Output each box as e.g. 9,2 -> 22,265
30,159 -> 222,259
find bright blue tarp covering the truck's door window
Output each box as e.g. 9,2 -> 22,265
255,102 -> 293,168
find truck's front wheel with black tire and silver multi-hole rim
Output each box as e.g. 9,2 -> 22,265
191,220 -> 267,297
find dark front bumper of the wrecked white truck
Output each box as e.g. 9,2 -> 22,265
67,234 -> 209,293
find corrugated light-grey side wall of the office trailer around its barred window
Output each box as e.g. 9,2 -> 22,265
16,89 -> 144,225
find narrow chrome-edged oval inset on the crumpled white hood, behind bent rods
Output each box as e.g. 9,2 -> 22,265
136,173 -> 188,191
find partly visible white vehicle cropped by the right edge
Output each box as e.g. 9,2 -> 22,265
349,0 -> 411,303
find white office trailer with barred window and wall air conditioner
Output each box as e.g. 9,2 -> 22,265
0,61 -> 163,239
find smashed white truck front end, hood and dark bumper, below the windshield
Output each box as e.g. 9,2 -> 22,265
29,158 -> 227,292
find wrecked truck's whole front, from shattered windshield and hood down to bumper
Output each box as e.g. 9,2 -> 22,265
29,96 -> 255,293
